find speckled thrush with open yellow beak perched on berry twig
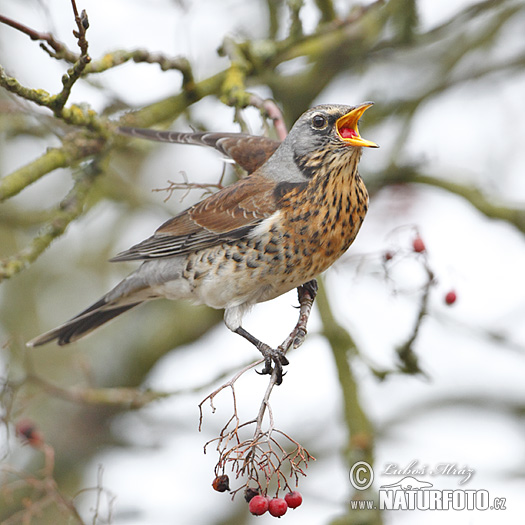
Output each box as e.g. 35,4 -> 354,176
28,103 -> 377,382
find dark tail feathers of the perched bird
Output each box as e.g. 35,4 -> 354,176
27,298 -> 143,346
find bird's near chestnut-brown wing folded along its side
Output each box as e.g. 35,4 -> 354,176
111,174 -> 277,261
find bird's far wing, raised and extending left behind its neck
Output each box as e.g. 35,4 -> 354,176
118,127 -> 280,173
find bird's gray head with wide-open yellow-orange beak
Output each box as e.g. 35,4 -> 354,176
267,102 -> 378,182
